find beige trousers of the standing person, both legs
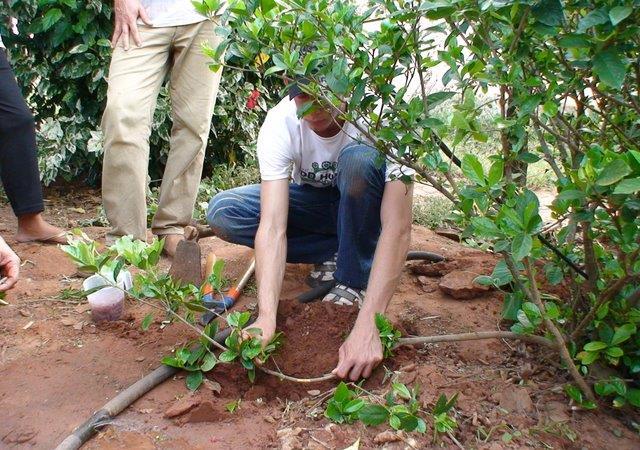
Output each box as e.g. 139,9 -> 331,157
102,20 -> 222,240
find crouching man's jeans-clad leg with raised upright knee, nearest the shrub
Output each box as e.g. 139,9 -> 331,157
334,144 -> 385,289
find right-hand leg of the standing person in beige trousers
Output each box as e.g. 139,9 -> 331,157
152,20 -> 222,254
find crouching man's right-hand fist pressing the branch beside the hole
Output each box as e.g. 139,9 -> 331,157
332,319 -> 383,381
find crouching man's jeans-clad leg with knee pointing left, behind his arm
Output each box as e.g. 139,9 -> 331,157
207,184 -> 338,264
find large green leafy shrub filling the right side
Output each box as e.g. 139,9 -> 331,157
201,0 -> 640,405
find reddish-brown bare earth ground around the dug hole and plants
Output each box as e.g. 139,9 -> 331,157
0,190 -> 640,450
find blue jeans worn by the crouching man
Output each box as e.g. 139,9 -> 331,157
207,143 -> 385,289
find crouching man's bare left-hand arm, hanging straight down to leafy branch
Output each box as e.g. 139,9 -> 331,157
252,179 -> 289,343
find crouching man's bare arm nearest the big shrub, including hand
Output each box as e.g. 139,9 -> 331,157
333,181 -> 413,381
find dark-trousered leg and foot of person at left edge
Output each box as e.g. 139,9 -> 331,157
0,26 -> 67,244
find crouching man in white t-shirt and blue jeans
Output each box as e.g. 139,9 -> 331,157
208,84 -> 413,380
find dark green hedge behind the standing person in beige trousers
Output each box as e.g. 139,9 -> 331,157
0,0 -> 272,184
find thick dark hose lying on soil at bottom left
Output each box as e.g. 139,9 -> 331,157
55,328 -> 231,450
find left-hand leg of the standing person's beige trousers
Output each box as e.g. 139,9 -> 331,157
102,25 -> 174,240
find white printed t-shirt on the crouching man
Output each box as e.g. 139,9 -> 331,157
258,97 -> 414,187
